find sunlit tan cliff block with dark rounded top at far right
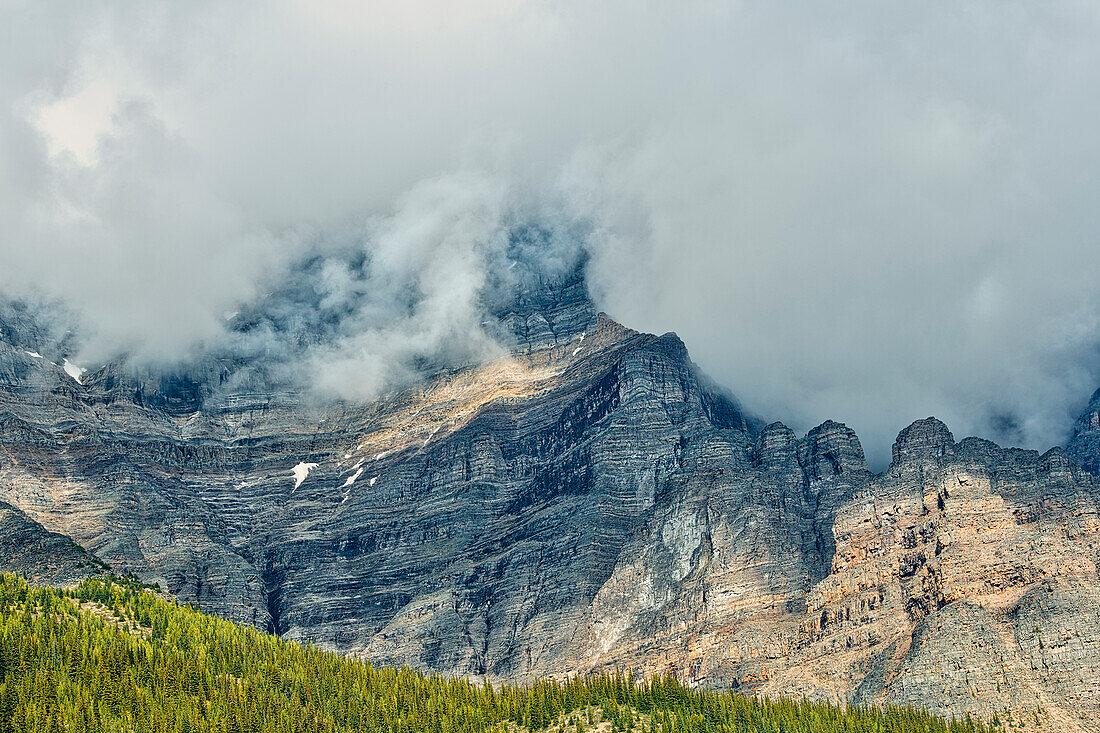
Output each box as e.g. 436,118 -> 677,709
805,418 -> 1100,725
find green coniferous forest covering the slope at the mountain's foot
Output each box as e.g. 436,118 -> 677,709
0,575 -> 991,733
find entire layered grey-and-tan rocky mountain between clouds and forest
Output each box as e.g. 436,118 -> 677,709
0,277 -> 1100,730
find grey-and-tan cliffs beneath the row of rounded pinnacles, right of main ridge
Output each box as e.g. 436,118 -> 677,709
558,418 -> 1100,730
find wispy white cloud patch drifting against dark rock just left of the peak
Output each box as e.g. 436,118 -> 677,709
297,175 -> 507,398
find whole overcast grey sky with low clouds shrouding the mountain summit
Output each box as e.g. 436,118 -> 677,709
0,0 -> 1100,466
